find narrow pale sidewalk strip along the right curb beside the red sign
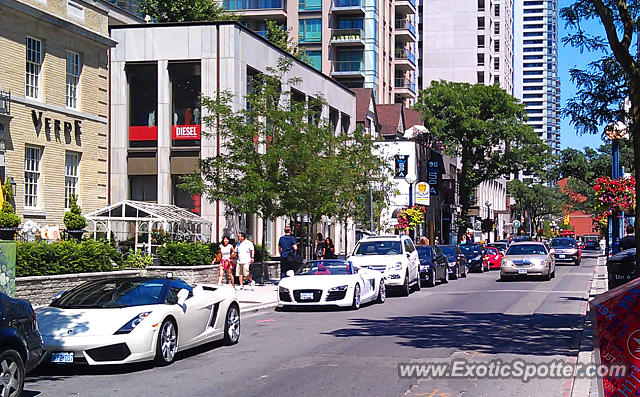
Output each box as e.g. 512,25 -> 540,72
571,256 -> 608,397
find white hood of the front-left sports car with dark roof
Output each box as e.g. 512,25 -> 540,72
36,305 -> 164,337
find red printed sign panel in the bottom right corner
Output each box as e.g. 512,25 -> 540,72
590,279 -> 640,397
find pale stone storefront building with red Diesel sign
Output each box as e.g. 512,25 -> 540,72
110,22 -> 356,255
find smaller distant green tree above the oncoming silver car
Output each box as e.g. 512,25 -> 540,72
507,179 -> 565,235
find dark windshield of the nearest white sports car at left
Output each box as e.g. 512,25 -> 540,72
51,278 -> 167,308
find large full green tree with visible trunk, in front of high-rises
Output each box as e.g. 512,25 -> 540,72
416,81 -> 549,240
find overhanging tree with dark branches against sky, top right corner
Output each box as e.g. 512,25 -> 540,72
560,0 -> 640,271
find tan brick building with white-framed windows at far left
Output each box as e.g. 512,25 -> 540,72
0,0 -> 134,225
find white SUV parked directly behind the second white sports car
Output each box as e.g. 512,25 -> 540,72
348,236 -> 420,296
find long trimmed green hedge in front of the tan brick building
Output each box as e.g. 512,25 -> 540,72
16,240 -> 122,277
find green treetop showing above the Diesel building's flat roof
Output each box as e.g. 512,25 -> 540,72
138,0 -> 235,22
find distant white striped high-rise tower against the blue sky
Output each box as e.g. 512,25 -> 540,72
514,0 -> 560,155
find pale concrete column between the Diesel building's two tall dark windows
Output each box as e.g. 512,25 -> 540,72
158,60 -> 171,204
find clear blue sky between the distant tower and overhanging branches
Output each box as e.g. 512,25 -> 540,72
558,0 -> 604,149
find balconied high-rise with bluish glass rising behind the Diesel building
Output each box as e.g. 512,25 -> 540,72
223,0 -> 417,105
